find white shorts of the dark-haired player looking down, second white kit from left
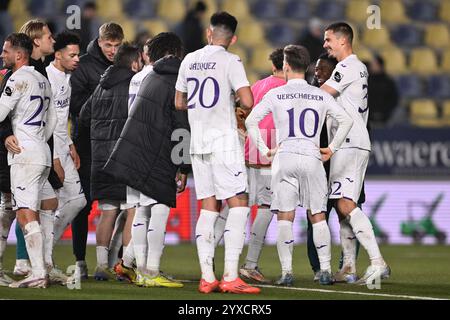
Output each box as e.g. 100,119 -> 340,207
57,153 -> 84,202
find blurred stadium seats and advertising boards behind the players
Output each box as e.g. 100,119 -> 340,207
0,0 -> 450,248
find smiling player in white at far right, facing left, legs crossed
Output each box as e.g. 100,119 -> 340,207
321,22 -> 390,284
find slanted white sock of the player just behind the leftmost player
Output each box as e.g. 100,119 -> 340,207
53,197 -> 86,244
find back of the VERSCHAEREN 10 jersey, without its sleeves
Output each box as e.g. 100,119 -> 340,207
263,79 -> 333,159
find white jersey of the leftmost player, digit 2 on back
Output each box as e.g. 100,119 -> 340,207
0,66 -> 52,166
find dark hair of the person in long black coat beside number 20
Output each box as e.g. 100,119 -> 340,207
144,32 -> 184,62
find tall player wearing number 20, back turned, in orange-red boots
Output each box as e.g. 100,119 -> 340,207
175,12 -> 260,293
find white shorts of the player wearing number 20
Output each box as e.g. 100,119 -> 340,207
191,150 -> 248,200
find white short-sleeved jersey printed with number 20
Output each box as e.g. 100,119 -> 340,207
176,45 -> 250,154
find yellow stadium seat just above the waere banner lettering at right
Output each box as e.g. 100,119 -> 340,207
410,99 -> 442,127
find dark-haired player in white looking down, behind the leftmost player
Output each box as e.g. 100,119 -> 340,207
46,32 -> 86,280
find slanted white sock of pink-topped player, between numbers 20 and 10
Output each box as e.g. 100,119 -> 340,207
245,208 -> 273,269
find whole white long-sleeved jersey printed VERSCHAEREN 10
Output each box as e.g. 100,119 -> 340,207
245,79 -> 352,159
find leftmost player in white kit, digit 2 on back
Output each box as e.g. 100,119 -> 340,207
0,33 -> 56,288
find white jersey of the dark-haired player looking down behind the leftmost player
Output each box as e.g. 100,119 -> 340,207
45,63 -> 73,156
